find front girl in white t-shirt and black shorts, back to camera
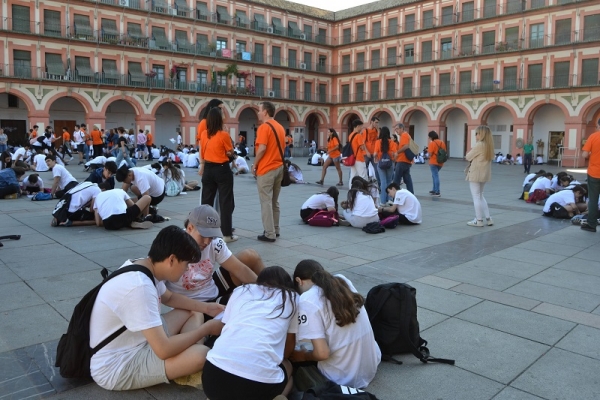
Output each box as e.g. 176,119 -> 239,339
202,267 -> 298,400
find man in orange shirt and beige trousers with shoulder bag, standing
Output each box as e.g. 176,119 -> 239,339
252,101 -> 285,243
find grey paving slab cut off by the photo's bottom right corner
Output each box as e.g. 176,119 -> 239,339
511,348 -> 600,400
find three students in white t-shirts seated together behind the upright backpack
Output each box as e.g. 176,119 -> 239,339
300,176 -> 422,228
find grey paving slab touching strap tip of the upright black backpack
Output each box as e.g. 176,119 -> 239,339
422,318 -> 549,384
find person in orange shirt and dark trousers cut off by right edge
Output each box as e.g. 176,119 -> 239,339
581,119 -> 600,232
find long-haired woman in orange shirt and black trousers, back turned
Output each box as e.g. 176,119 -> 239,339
198,107 -> 238,243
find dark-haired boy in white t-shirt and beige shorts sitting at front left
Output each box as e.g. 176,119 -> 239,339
90,226 -> 224,390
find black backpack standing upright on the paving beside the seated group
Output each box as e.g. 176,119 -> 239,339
365,283 -> 454,365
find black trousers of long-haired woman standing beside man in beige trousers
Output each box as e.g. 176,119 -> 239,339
202,162 -> 235,236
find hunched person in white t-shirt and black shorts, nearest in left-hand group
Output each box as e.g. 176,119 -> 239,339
92,189 -> 153,231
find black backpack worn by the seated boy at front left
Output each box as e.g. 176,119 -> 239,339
54,264 -> 154,378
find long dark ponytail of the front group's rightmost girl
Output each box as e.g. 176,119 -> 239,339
294,260 -> 365,326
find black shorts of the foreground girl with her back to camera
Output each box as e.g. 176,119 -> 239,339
202,361 -> 288,400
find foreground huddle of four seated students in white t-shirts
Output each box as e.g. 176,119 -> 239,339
90,209 -> 381,400
